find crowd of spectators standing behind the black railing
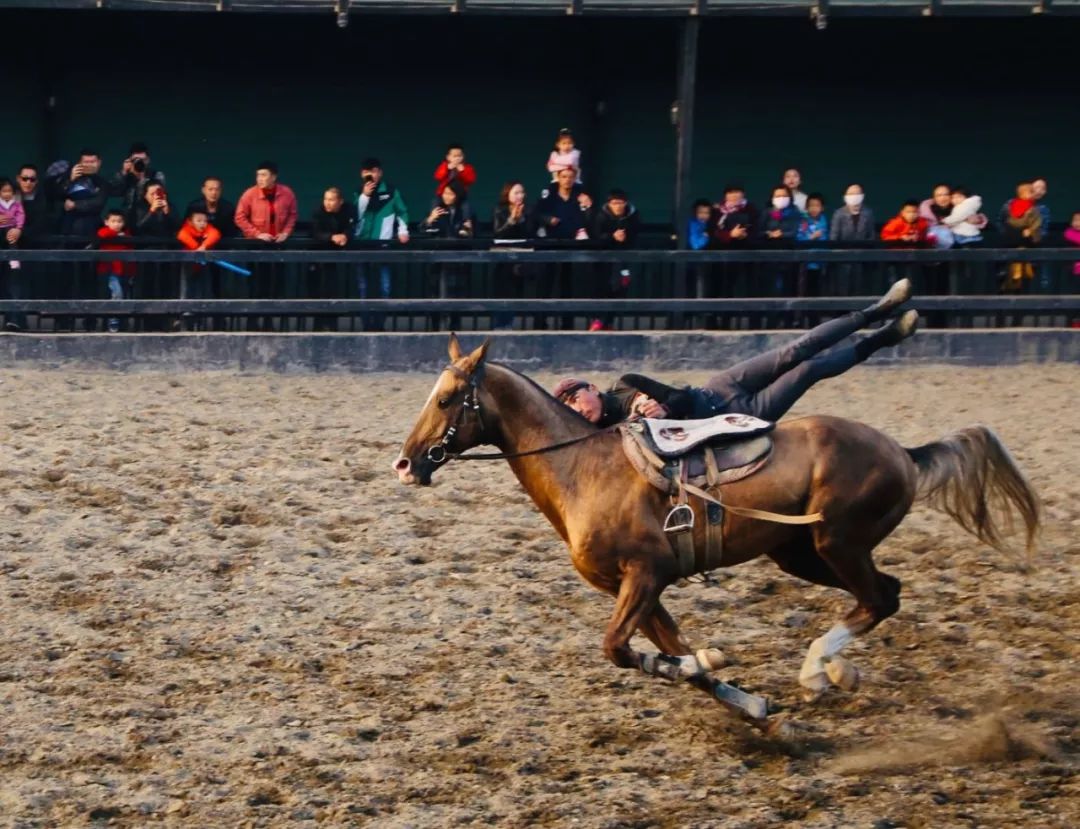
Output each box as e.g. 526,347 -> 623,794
0,130 -> 1080,330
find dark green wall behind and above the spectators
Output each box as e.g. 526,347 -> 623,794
6,12 -> 1080,221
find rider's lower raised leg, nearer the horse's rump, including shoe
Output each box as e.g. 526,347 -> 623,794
745,311 -> 919,421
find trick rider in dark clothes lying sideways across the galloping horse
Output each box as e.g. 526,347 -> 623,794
552,280 -> 919,426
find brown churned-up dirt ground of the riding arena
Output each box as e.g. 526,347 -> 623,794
0,367 -> 1080,829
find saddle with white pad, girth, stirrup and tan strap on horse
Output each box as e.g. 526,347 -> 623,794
618,415 -> 822,579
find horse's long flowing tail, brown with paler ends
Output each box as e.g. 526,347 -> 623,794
906,426 -> 1041,562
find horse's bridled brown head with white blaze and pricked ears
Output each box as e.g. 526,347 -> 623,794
394,334 -> 491,486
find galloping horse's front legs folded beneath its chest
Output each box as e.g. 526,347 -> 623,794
604,568 -> 768,720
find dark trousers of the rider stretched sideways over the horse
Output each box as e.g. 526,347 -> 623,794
705,311 -> 869,421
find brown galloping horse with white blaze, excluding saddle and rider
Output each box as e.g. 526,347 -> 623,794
394,335 -> 1039,718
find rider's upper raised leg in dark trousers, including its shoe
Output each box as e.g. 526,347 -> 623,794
705,280 -> 912,394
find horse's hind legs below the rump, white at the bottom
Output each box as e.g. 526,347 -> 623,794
799,547 -> 900,701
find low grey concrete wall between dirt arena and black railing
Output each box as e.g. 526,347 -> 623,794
0,328 -> 1080,372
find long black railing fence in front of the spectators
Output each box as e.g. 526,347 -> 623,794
0,243 -> 1080,331
